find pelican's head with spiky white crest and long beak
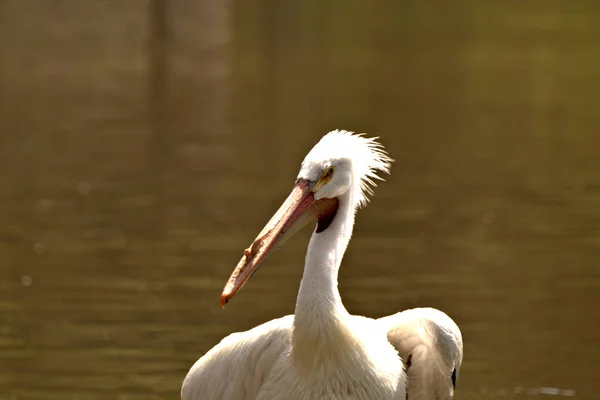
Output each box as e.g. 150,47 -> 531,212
221,130 -> 392,306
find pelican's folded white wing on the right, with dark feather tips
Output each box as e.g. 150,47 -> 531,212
377,308 -> 463,400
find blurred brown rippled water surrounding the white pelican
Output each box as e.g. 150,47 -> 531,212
0,0 -> 600,400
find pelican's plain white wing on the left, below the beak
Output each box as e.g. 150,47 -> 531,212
181,315 -> 294,400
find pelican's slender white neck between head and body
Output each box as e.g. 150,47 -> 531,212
292,192 -> 354,368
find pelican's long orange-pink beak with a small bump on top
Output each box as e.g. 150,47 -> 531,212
221,180 -> 338,307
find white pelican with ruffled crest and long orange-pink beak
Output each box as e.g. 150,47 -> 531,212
181,130 -> 463,400
